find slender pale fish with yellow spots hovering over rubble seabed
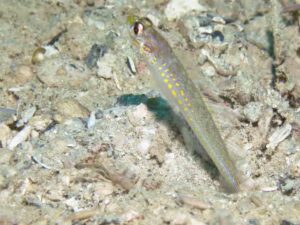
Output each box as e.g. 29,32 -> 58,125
128,16 -> 239,192
